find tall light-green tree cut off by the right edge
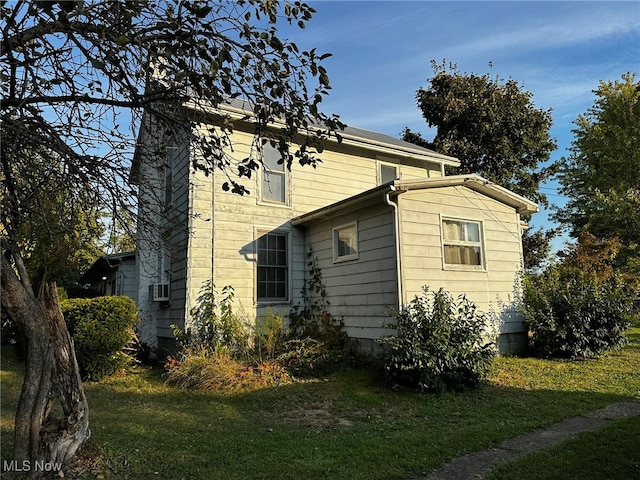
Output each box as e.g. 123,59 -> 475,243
555,73 -> 640,275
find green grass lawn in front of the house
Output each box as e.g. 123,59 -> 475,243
0,328 -> 640,480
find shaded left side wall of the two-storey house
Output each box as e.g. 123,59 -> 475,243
136,116 -> 190,349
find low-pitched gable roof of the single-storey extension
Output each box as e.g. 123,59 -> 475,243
291,174 -> 538,225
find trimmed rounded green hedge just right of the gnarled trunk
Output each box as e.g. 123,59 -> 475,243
61,296 -> 137,381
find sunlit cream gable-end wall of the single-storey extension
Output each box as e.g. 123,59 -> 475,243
398,186 -> 526,350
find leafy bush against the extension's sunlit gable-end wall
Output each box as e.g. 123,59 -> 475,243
381,287 -> 496,392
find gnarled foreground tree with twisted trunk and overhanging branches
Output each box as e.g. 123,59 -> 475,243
0,0 -> 342,472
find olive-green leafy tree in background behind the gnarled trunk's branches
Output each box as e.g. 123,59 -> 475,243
0,146 -> 103,288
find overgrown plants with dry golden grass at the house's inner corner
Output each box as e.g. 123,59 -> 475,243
165,262 -> 362,391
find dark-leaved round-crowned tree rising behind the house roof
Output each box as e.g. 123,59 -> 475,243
403,61 -> 557,267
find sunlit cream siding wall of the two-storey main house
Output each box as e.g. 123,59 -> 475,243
180,128 -> 440,328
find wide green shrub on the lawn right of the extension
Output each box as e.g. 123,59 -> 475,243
522,269 -> 633,359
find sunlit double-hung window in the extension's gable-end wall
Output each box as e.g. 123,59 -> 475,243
442,218 -> 484,270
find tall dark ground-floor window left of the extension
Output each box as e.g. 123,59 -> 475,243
257,233 -> 289,302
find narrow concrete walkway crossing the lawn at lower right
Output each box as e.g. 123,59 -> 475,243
410,400 -> 640,480
